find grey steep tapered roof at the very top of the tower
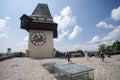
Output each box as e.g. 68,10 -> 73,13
32,3 -> 51,17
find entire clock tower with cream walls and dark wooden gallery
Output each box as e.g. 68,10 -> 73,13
20,3 -> 57,57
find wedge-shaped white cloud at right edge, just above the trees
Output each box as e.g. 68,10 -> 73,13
102,26 -> 120,41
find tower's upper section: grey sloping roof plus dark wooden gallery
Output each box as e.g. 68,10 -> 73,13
20,3 -> 58,38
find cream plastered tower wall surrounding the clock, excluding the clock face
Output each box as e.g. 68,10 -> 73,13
28,30 -> 55,57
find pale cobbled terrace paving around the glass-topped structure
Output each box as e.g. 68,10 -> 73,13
0,55 -> 120,80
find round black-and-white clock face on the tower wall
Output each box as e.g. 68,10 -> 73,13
30,32 -> 46,46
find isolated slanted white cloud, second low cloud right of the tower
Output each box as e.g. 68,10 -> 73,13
69,25 -> 83,40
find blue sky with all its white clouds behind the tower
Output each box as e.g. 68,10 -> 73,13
0,0 -> 120,52
